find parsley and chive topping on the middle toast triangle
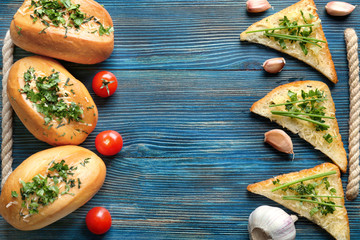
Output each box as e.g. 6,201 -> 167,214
269,89 -> 335,143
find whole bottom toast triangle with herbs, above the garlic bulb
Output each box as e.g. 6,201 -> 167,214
247,163 -> 350,240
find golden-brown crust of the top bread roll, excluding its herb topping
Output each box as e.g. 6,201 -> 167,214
10,0 -> 114,64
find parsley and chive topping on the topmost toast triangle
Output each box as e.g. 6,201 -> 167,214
246,10 -> 326,55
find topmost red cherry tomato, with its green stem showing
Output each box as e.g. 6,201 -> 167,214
92,71 -> 118,97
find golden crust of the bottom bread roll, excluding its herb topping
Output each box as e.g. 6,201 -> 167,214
0,146 -> 106,231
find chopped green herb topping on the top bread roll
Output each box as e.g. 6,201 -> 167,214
30,0 -> 114,38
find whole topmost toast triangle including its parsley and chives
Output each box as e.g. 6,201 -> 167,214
240,0 -> 338,83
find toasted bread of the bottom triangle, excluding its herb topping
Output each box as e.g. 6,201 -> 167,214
247,163 -> 350,240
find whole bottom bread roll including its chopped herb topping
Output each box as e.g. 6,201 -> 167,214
0,146 -> 106,231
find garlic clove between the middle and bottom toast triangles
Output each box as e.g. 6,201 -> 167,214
264,129 -> 294,154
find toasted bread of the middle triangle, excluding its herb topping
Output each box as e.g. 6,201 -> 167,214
250,81 -> 347,173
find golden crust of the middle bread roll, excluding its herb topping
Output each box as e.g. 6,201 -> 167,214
7,56 -> 98,146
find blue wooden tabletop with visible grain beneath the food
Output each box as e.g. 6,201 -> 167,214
0,0 -> 360,239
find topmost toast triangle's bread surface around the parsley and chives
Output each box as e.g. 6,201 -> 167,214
240,0 -> 338,83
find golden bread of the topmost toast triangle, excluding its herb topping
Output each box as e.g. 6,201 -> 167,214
240,0 -> 338,83
